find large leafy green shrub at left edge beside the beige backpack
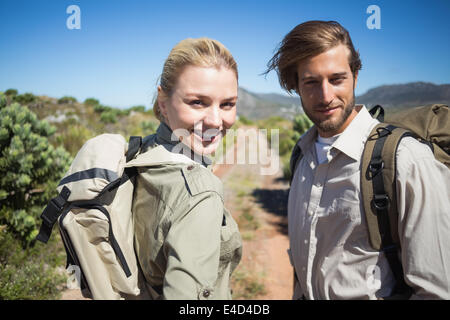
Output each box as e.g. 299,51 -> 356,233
0,94 -> 71,245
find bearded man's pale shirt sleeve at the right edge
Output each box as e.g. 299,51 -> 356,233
397,138 -> 450,299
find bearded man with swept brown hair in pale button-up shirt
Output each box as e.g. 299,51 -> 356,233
267,21 -> 450,299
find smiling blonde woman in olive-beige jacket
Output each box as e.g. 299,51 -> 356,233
133,38 -> 242,299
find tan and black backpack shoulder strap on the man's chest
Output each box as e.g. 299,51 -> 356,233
361,123 -> 411,293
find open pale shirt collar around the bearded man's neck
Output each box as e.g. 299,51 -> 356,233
298,105 -> 378,161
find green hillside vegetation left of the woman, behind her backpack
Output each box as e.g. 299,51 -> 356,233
0,89 -> 158,300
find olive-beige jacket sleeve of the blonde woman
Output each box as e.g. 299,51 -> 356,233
163,192 -> 223,300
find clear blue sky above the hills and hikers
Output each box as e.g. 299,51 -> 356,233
0,0 -> 450,107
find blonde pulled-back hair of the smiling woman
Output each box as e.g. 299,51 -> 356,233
153,38 -> 238,121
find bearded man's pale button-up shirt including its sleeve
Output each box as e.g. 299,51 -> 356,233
288,107 -> 450,299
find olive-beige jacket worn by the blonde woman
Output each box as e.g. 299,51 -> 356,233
133,123 -> 242,299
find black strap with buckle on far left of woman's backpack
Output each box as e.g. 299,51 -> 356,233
36,186 -> 70,243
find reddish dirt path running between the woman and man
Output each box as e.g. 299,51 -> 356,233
62,128 -> 293,300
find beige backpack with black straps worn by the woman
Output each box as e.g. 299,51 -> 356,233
36,134 -> 200,300
